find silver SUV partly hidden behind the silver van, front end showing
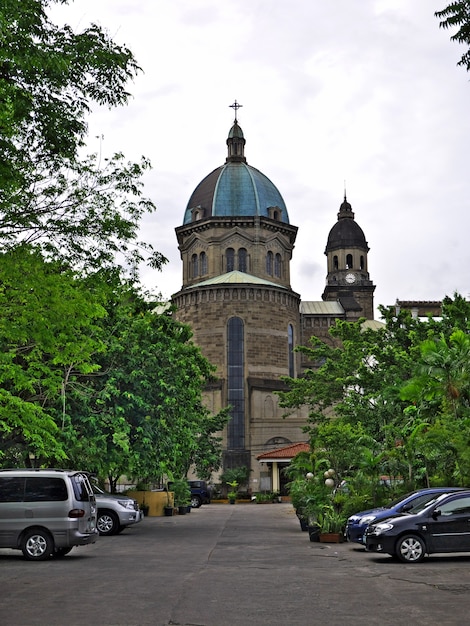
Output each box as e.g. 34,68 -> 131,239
93,483 -> 143,535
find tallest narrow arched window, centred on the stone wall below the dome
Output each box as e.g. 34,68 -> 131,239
227,317 -> 245,450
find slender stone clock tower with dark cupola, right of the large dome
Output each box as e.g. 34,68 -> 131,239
322,194 -> 375,321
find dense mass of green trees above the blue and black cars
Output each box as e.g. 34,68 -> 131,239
279,294 -> 470,510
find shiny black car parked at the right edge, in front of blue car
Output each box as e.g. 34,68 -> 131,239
365,490 -> 470,563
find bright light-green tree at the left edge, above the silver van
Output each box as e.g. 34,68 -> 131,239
0,246 -> 105,461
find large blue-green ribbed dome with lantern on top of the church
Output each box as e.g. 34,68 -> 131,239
183,120 -> 289,224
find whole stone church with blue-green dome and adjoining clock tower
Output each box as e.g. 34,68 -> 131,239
172,107 -> 375,492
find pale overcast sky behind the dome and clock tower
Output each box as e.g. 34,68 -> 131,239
49,0 -> 470,316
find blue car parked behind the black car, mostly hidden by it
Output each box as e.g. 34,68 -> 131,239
344,487 -> 462,545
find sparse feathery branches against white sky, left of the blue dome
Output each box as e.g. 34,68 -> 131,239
0,154 -> 166,278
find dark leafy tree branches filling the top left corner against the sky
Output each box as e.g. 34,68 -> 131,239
0,0 -> 139,200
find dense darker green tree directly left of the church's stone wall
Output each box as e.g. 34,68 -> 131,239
60,280 -> 228,484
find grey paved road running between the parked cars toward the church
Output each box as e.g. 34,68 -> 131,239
0,504 -> 470,626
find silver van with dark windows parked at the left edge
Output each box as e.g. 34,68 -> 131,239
0,469 -> 98,561
